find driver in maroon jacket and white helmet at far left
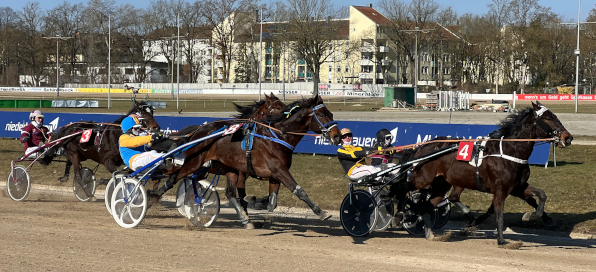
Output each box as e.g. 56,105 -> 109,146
20,110 -> 50,158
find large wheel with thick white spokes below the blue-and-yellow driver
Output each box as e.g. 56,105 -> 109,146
111,178 -> 147,228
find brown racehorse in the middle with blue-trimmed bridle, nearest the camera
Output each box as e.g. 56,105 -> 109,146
150,96 -> 340,228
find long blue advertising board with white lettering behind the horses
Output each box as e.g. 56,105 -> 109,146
0,112 -> 550,165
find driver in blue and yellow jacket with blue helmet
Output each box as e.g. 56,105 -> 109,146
118,115 -> 170,170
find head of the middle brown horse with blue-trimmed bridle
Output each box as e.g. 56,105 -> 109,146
305,95 -> 341,145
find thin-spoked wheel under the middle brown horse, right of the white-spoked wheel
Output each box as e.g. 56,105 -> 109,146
181,180 -> 220,227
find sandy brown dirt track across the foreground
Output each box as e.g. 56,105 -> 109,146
0,187 -> 596,271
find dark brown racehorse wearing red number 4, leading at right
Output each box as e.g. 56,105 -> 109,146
410,102 -> 573,245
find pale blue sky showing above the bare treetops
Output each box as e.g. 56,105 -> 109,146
0,0 -> 596,22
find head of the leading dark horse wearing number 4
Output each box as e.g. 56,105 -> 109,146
532,101 -> 573,148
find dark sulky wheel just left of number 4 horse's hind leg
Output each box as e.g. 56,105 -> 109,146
402,191 -> 428,235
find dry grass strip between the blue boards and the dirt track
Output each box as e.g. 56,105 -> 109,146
0,139 -> 596,234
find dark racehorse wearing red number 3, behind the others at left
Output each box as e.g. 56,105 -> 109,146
42,101 -> 160,196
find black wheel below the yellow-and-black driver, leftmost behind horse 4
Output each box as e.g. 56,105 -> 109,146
339,190 -> 378,237
